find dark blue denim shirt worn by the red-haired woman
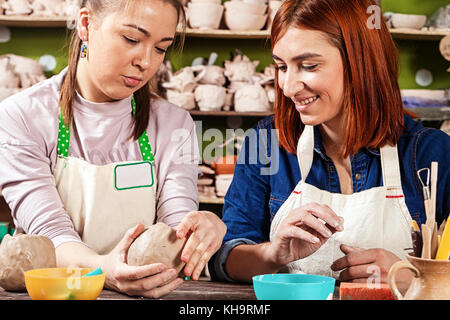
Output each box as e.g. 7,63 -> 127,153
209,115 -> 450,281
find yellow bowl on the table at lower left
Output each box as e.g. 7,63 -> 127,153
25,268 -> 105,300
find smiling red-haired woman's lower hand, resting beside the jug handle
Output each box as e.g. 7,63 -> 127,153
331,244 -> 414,291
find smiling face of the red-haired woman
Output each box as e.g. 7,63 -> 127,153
273,27 -> 344,125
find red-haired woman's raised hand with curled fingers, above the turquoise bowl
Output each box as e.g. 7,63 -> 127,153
268,203 -> 344,267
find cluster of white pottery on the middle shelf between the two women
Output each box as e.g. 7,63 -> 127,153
161,50 -> 275,113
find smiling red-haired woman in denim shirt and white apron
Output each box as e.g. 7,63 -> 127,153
209,0 -> 450,292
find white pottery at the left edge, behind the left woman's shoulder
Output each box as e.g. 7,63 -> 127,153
0,54 -> 46,101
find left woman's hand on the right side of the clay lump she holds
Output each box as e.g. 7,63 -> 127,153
177,211 -> 227,280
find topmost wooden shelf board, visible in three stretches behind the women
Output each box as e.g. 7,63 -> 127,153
0,15 -> 450,40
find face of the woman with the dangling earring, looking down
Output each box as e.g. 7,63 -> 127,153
82,1 -> 178,101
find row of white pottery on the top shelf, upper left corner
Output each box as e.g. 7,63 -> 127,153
0,0 -> 81,17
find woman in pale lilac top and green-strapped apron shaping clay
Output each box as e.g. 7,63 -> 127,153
0,0 -> 226,297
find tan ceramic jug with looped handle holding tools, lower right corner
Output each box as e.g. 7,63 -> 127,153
388,255 -> 450,300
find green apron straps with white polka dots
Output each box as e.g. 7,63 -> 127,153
58,96 -> 154,162
